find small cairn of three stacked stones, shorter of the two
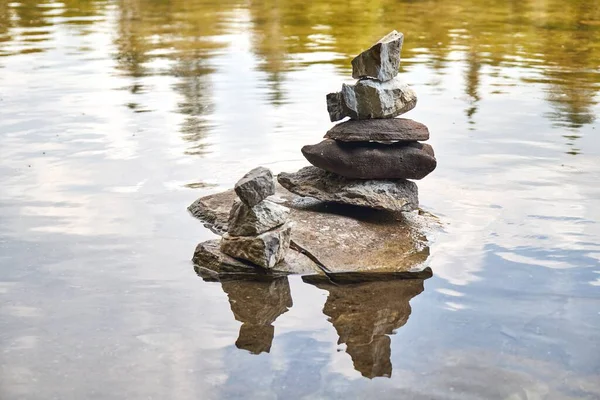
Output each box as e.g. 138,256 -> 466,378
221,167 -> 291,269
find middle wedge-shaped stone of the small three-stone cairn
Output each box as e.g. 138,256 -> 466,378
227,200 -> 290,236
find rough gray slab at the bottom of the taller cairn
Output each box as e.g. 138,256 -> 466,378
277,167 -> 419,212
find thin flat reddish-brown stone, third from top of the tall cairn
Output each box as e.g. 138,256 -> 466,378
325,118 -> 429,142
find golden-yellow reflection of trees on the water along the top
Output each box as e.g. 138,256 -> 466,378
0,0 -> 600,131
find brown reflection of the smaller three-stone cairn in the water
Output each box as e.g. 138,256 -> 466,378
196,269 -> 292,354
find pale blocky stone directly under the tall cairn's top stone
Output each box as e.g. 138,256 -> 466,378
327,77 -> 417,122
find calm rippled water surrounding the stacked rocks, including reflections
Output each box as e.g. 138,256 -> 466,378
0,0 -> 600,400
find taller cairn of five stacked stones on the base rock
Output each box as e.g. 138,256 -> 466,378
279,31 -> 437,212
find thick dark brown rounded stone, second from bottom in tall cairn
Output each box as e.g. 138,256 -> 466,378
302,139 -> 437,179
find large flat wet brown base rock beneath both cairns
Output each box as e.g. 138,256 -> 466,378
188,181 -> 435,282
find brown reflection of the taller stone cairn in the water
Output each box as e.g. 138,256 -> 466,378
304,279 -> 423,378
